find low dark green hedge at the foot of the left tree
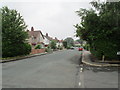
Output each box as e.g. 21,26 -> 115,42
2,43 -> 31,58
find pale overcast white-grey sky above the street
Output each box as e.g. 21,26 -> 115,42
0,0 -> 94,39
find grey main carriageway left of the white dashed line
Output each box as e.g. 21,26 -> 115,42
2,50 -> 81,88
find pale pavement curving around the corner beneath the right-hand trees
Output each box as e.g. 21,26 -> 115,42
82,51 -> 120,67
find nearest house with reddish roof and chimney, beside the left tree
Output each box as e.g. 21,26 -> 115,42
27,27 -> 44,47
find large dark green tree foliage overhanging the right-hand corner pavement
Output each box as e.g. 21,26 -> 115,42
75,1 -> 120,59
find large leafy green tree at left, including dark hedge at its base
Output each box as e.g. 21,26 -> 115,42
1,7 -> 31,57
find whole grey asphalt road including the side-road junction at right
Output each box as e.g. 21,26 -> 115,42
2,50 -> 118,88
